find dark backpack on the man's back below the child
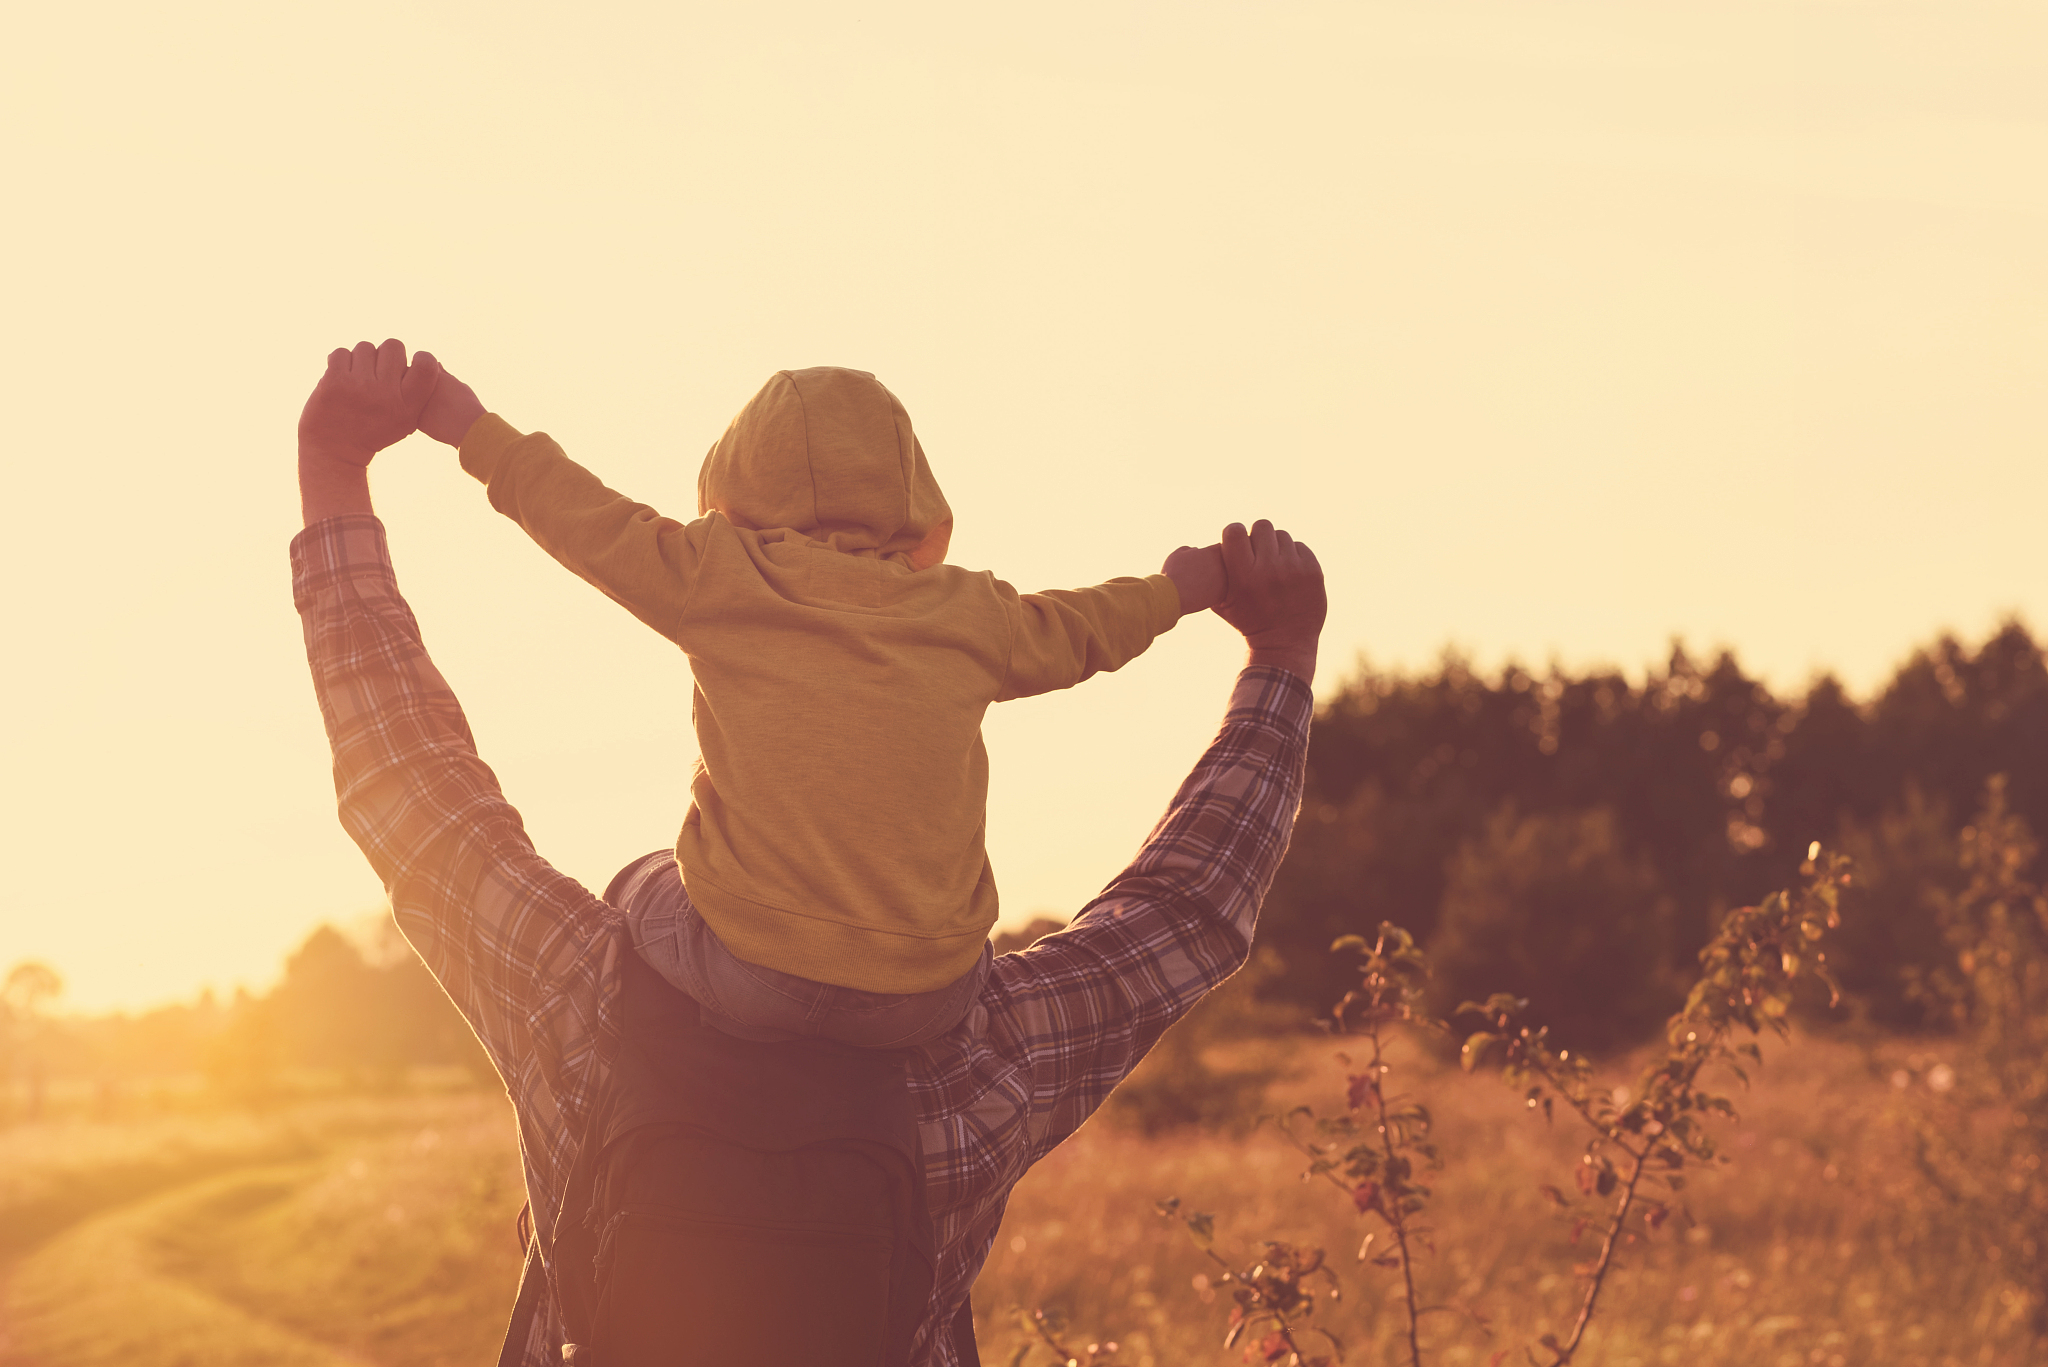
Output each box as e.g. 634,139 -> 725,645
547,953 -> 977,1367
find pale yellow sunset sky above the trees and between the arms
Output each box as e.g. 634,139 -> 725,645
0,0 -> 2048,1010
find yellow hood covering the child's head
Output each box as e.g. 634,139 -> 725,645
696,365 -> 952,570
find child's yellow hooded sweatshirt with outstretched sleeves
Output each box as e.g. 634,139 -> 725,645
461,367 -> 1180,992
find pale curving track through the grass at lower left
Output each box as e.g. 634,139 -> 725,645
0,1164 -> 369,1367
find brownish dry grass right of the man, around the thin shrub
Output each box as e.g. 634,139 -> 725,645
975,1039 -> 2048,1367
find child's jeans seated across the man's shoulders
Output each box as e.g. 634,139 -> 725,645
606,851 -> 993,1049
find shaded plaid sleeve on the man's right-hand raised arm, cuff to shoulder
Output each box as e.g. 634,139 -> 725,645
989,666 -> 1315,1164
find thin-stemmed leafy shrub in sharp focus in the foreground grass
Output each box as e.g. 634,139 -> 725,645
1130,848 -> 1851,1367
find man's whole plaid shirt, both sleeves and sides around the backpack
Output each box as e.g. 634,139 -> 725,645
291,514 -> 1313,1367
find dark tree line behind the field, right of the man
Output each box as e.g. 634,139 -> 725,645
1262,621 -> 2048,1047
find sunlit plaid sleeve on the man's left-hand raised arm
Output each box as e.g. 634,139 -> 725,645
291,514 -> 629,1254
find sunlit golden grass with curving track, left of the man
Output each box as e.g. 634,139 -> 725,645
0,1092 -> 520,1367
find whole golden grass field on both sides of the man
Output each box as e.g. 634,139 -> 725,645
0,1039 -> 2044,1367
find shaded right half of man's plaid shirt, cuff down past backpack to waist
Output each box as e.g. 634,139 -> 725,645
911,666 -> 1315,1367
